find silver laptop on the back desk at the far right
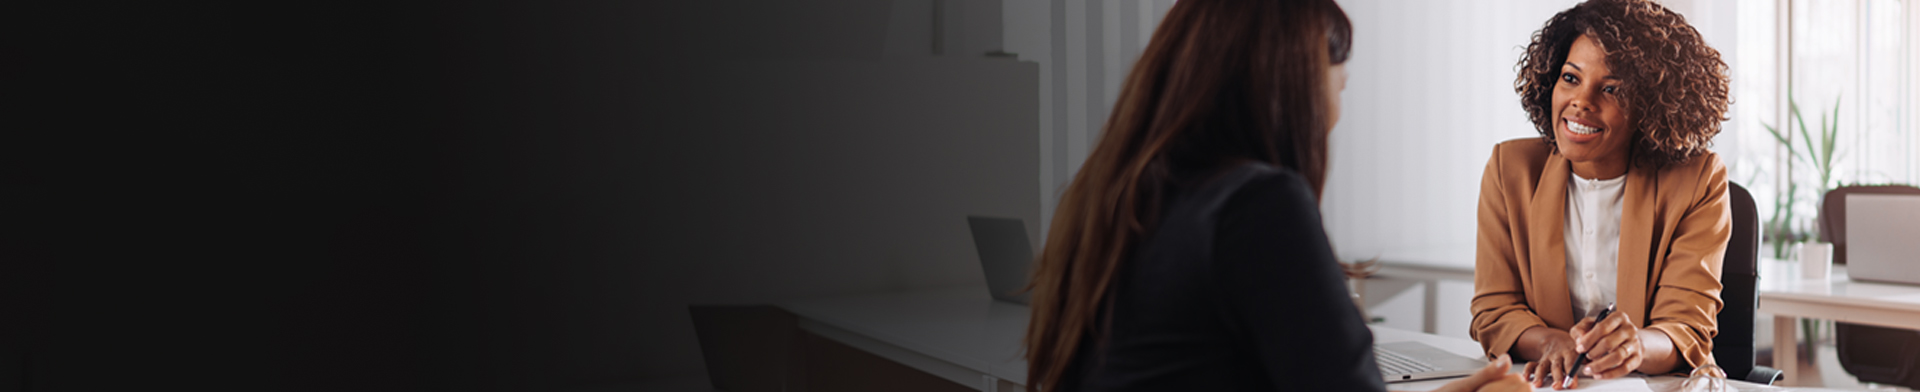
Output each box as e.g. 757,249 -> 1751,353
1847,194 -> 1920,284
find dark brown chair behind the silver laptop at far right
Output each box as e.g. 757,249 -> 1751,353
1820,184 -> 1920,388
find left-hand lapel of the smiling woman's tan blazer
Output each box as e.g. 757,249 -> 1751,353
1528,154 -> 1574,329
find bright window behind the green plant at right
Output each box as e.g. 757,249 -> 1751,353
1720,0 -> 1920,257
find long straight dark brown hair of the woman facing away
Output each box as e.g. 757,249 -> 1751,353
1025,0 -> 1352,392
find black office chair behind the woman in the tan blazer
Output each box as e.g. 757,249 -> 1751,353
1713,183 -> 1780,384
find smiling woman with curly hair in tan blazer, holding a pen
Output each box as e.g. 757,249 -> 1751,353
1471,0 -> 1732,388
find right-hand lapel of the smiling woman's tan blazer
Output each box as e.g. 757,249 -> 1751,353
1615,169 -> 1659,327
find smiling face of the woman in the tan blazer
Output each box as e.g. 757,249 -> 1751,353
1553,35 -> 1636,179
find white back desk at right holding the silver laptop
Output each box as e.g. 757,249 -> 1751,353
1759,259 -> 1920,382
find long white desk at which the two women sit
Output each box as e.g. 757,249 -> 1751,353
778,288 -> 1782,392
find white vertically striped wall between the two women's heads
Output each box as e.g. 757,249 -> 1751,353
1321,0 -> 1574,259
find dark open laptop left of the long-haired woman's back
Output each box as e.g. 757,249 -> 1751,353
966,215 -> 1033,306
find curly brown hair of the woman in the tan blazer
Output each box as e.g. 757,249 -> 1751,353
1513,0 -> 1730,169
